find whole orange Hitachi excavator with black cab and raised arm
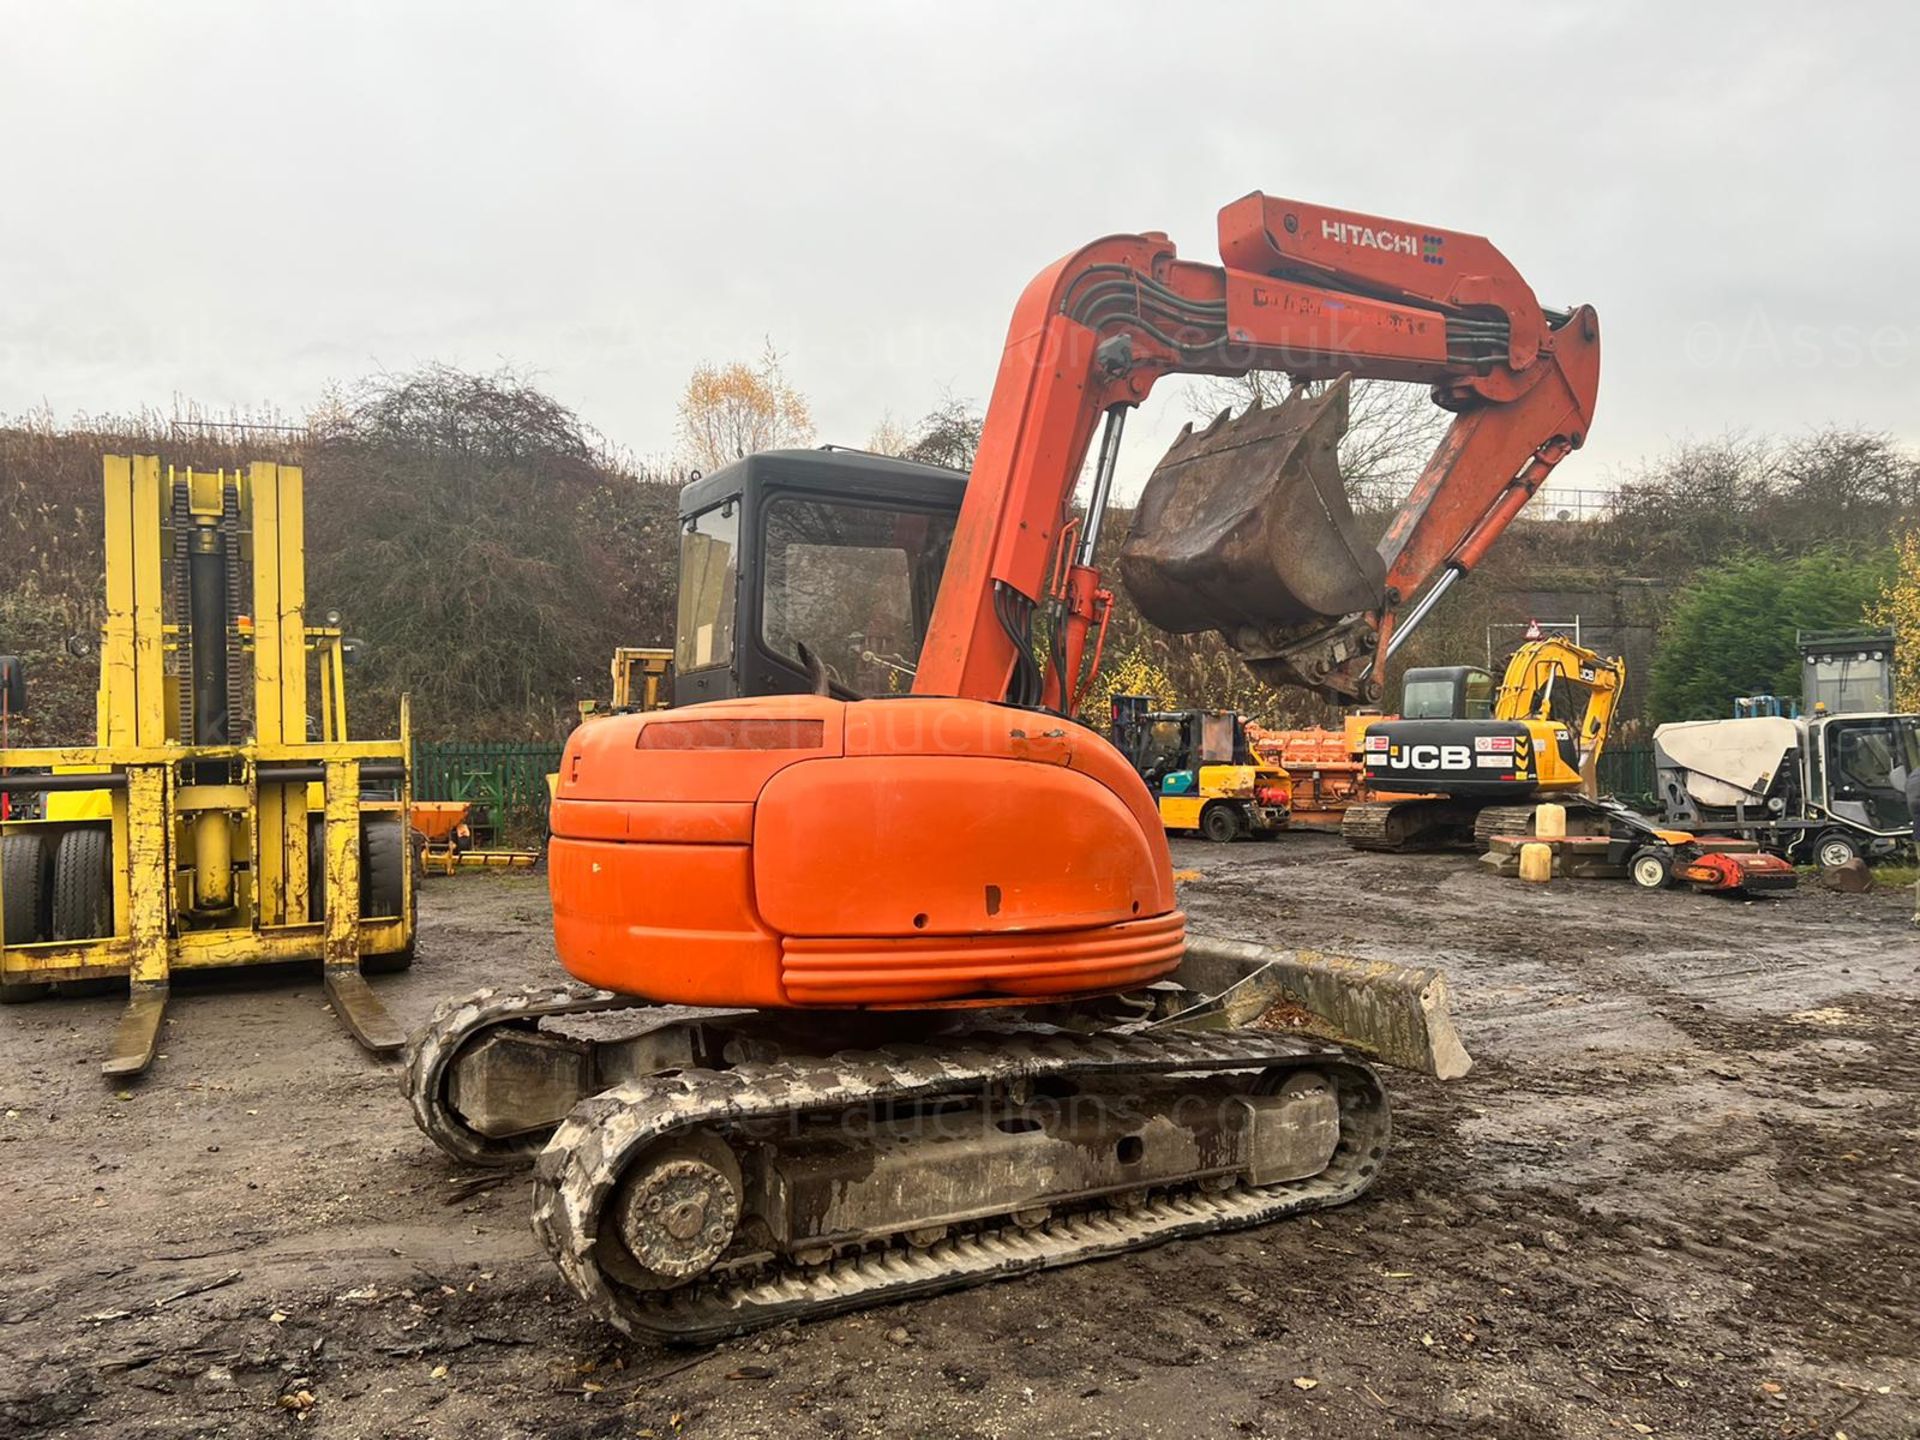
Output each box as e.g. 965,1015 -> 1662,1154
407,194 -> 1599,1342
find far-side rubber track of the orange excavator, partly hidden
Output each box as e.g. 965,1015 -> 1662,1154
401,985 -> 645,1167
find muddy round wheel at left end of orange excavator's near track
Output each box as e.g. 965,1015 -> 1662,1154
612,1135 -> 741,1290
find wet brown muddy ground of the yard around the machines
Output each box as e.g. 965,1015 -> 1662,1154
0,835 -> 1920,1440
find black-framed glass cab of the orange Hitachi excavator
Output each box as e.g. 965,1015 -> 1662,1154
674,447 -> 966,707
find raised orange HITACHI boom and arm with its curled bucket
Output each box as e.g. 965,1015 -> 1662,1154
914,192 -> 1599,708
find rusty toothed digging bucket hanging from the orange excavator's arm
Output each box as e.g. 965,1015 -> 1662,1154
1119,376 -> 1386,684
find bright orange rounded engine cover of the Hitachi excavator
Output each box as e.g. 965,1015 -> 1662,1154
549,695 -> 1185,1008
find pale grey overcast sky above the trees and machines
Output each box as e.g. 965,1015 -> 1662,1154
0,0 -> 1920,506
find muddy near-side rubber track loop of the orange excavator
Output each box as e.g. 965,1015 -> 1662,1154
534,1031 -> 1390,1344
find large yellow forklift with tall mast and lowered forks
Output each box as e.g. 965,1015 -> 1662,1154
0,455 -> 415,1075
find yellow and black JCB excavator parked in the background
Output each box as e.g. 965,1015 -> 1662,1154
1340,636 -> 1626,851
